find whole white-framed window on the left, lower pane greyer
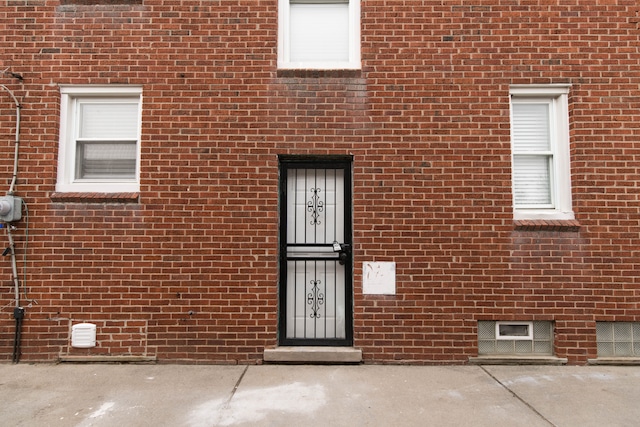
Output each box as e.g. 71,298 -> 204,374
56,86 -> 142,193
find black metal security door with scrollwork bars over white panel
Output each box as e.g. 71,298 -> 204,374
279,158 -> 353,346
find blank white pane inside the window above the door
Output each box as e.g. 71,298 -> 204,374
290,3 -> 349,62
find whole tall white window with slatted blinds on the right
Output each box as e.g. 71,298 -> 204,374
510,85 -> 574,220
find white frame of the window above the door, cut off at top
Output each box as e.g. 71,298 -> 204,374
278,0 -> 361,70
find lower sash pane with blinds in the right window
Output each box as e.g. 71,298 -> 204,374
513,156 -> 551,206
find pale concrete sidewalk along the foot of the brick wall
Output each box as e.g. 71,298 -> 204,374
0,364 -> 640,427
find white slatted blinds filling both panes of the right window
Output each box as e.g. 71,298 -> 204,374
512,103 -> 553,207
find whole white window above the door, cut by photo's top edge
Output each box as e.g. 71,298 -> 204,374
278,0 -> 360,70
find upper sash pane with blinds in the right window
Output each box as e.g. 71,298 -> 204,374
513,103 -> 551,153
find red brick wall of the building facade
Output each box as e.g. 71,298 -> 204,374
0,0 -> 640,363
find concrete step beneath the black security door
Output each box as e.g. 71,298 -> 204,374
263,347 -> 362,364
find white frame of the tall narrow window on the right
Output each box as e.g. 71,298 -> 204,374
509,84 -> 575,220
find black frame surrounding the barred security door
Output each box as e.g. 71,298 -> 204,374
278,155 -> 354,346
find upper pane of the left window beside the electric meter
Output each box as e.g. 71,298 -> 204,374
78,102 -> 138,139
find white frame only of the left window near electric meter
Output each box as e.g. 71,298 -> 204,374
56,85 -> 142,193
